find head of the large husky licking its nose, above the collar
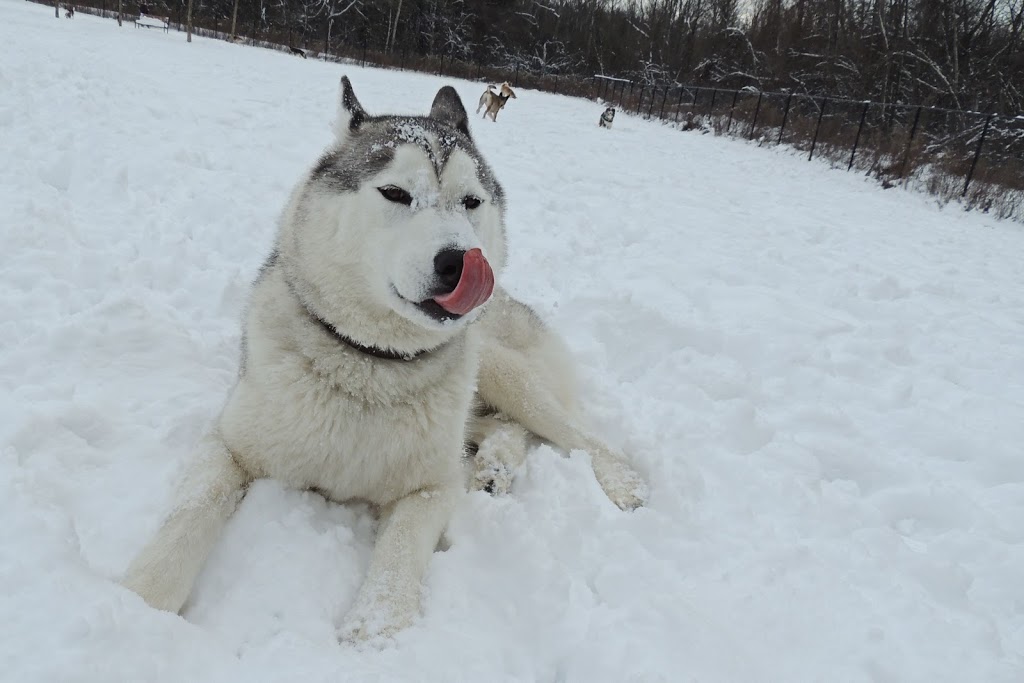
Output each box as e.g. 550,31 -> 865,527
278,77 -> 506,353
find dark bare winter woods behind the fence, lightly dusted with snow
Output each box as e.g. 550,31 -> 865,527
74,0 -> 1024,115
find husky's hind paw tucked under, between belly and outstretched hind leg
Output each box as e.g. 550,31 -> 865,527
468,415 -> 528,495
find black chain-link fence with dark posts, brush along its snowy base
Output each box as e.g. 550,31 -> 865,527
590,76 -> 1024,220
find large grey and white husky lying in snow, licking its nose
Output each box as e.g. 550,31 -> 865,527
124,78 -> 645,640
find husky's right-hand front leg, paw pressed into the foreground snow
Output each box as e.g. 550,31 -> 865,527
339,487 -> 461,641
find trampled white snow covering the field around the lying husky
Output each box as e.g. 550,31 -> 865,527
0,0 -> 1024,683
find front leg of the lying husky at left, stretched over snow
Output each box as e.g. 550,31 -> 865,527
122,434 -> 250,612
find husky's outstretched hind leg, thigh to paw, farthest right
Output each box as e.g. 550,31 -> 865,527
478,344 -> 647,510
